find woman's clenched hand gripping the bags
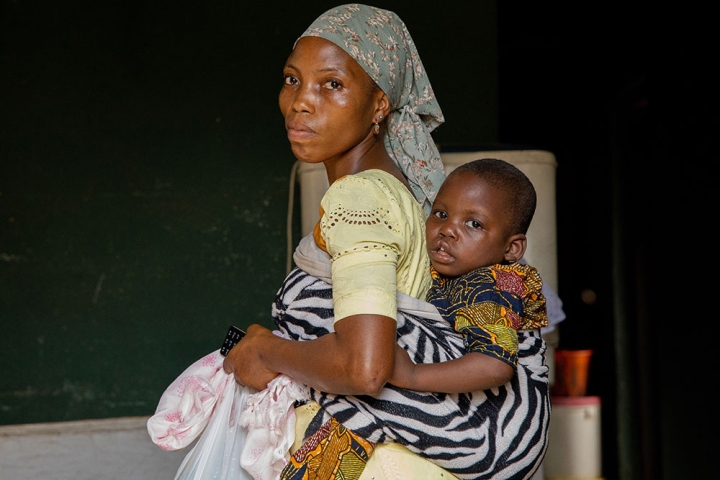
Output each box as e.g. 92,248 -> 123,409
223,324 -> 283,390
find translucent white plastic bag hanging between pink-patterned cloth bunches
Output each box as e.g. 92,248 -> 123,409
175,375 -> 253,480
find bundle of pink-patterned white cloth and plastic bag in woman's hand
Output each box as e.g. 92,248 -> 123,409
147,350 -> 309,480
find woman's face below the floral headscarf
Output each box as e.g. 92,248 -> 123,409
279,37 -> 382,163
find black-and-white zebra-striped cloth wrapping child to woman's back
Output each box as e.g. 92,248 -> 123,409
273,237 -> 550,480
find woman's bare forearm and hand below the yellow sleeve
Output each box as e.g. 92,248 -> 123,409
223,315 -> 396,395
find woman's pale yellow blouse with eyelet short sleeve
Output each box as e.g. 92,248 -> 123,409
320,170 -> 430,321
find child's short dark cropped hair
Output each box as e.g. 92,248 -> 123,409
449,158 -> 537,235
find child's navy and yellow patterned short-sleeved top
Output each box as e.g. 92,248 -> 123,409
427,263 -> 548,367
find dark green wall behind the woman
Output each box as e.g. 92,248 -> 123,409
0,0 -> 497,424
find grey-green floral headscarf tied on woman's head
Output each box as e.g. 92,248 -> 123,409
301,3 -> 445,213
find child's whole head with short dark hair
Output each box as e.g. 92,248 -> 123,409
426,158 -> 537,277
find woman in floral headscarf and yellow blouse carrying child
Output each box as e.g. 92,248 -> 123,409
224,4 -> 549,479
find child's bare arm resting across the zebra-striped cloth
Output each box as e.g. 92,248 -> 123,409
389,345 -> 515,393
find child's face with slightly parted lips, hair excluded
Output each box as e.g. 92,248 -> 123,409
425,172 -> 509,277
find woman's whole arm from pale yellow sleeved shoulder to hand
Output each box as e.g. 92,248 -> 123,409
224,171 -> 416,395
